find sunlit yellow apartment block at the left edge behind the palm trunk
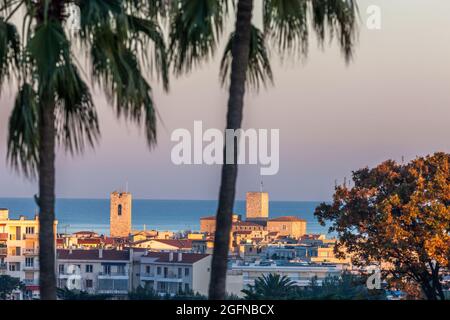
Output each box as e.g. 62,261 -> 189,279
0,209 -> 57,299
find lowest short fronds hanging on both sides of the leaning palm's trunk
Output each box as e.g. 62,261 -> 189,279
220,25 -> 273,90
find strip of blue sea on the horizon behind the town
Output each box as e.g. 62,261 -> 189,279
0,198 -> 328,235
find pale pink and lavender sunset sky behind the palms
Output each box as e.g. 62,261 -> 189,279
0,0 -> 450,201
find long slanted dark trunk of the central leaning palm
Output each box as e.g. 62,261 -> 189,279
209,0 -> 253,299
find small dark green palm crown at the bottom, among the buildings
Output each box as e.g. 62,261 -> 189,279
242,273 -> 297,300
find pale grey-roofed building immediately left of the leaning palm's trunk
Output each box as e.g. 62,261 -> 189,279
137,252 -> 211,295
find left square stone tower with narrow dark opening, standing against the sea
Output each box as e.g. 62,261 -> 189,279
109,191 -> 131,237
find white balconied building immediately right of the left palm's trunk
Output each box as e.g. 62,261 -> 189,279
57,249 -> 132,297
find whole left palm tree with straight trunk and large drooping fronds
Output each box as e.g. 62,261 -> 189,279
0,0 -> 168,299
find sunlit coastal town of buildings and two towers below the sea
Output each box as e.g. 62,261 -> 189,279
0,192 -> 448,299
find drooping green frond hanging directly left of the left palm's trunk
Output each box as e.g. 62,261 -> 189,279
7,83 -> 39,178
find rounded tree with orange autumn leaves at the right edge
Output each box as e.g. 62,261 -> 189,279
315,153 -> 450,299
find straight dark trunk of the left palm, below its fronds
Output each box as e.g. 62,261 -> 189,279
38,103 -> 56,300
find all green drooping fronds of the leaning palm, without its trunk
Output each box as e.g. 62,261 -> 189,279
169,0 -> 358,90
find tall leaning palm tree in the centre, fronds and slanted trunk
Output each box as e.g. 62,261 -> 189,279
165,0 -> 357,299
